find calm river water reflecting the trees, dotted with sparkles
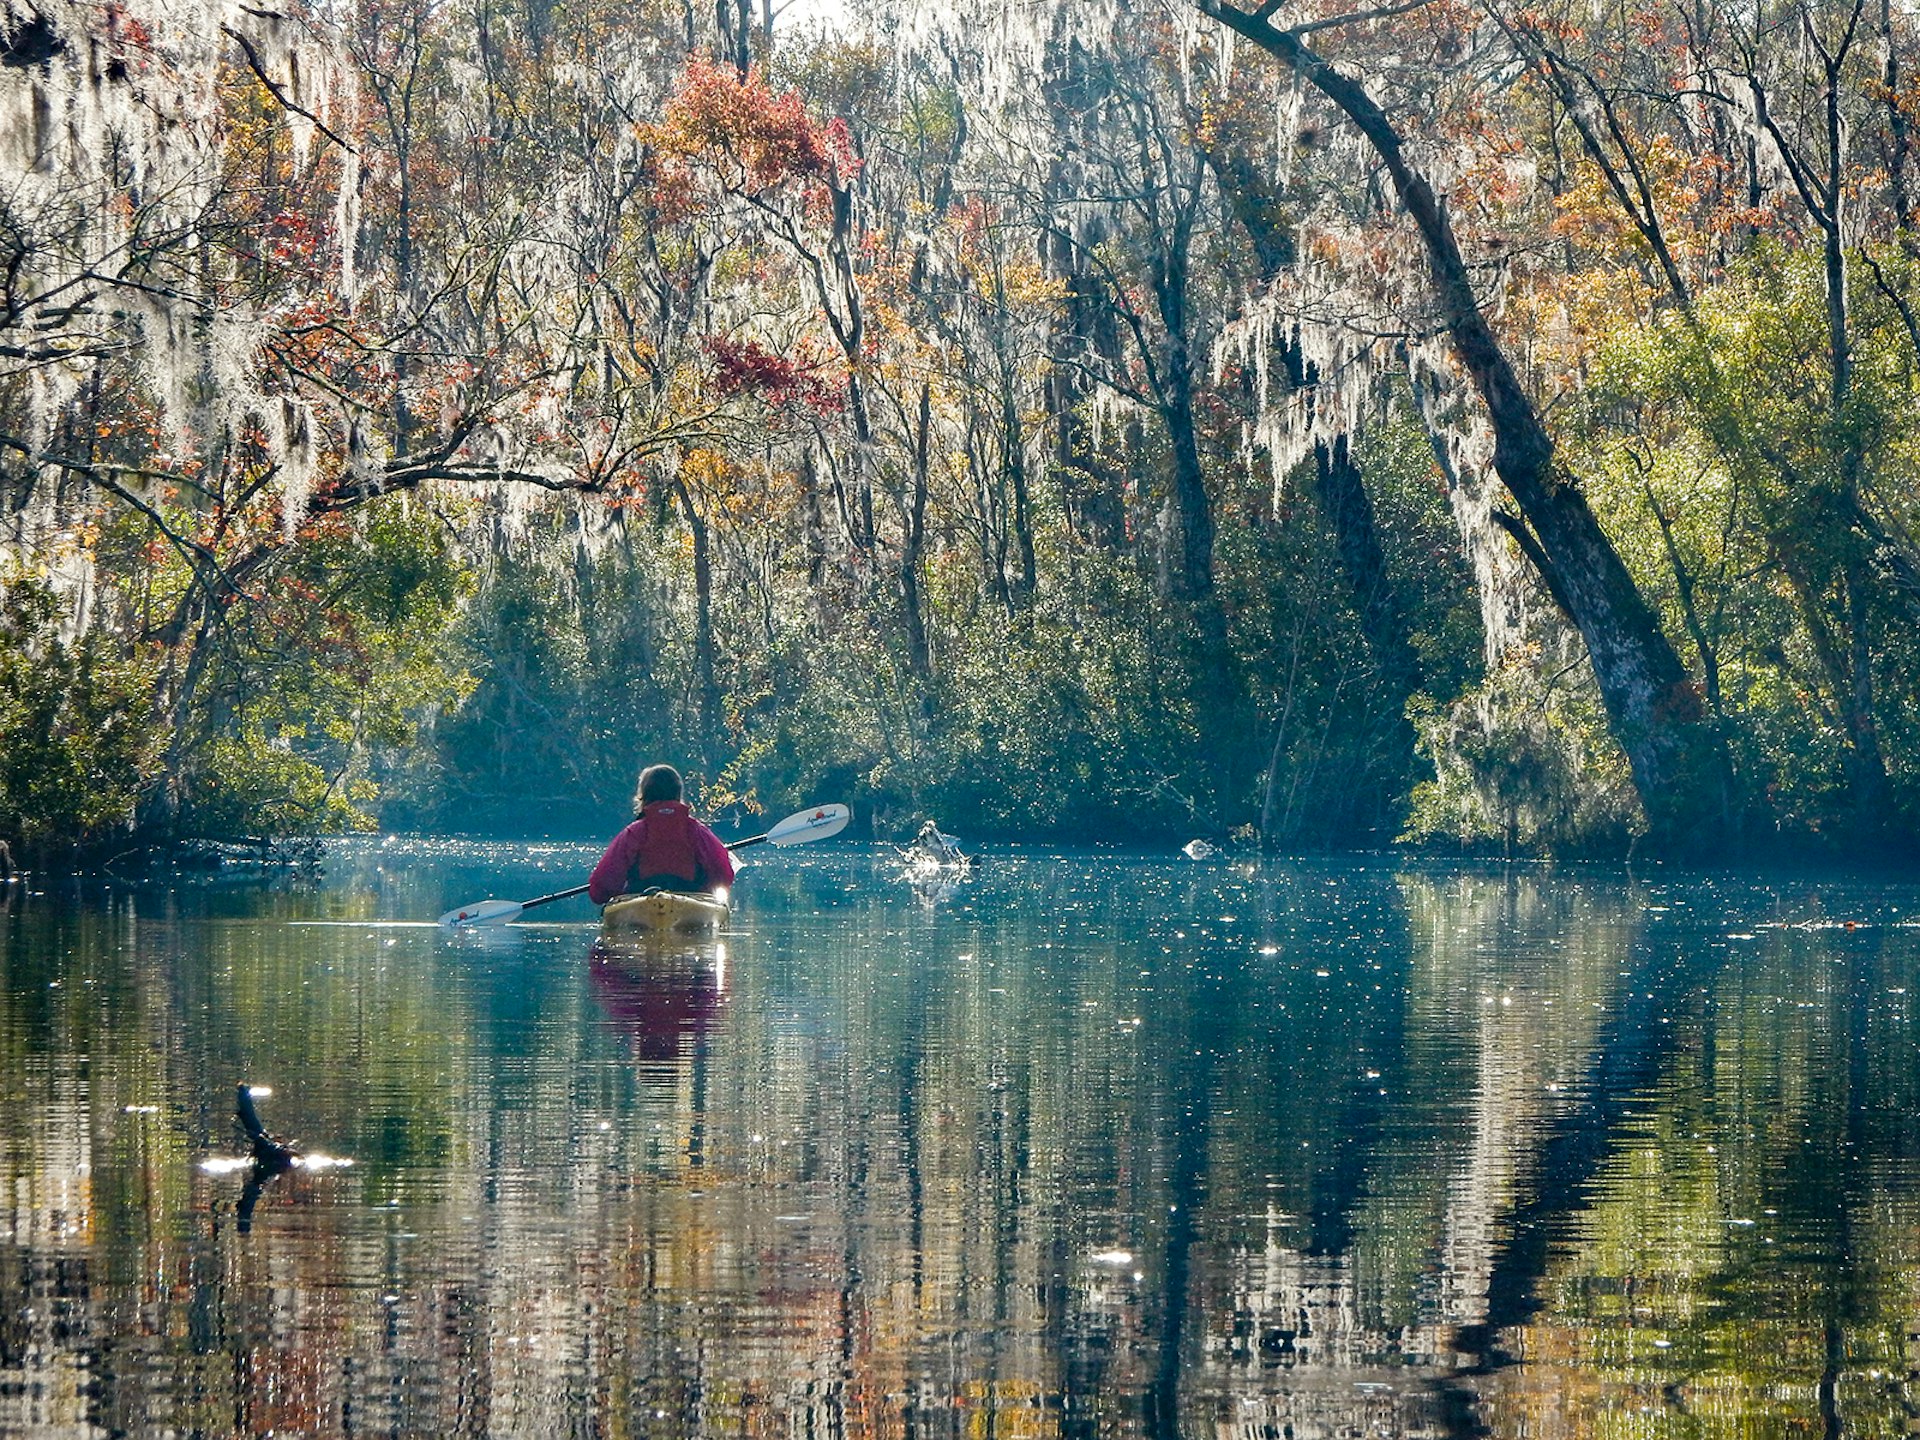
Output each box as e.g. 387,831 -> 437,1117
0,843 -> 1920,1440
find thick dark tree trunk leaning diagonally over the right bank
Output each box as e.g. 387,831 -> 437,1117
1194,0 -> 1734,851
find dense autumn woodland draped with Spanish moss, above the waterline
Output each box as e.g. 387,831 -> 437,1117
0,0 -> 1920,864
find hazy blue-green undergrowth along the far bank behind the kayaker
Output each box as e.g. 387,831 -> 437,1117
382,384 -> 1480,845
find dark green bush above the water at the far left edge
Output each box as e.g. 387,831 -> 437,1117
0,570 -> 161,860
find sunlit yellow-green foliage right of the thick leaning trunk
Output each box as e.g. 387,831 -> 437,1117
1576,246 -> 1920,837
